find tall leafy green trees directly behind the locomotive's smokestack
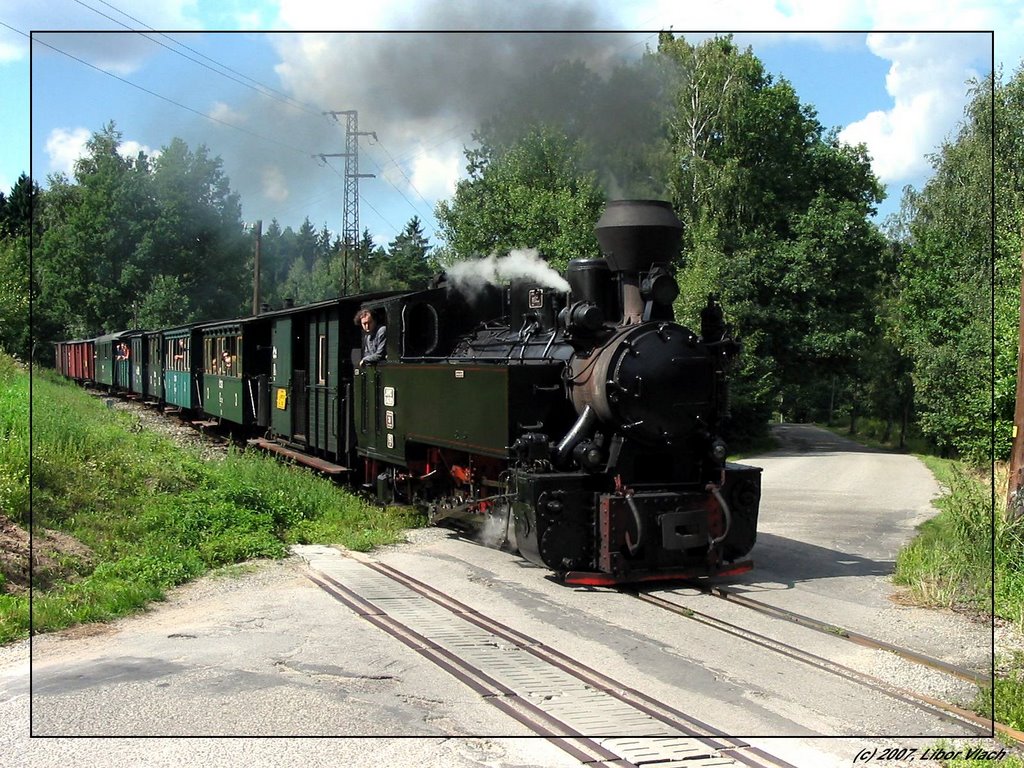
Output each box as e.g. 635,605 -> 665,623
437,34 -> 885,444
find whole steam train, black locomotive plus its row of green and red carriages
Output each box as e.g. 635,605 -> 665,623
56,201 -> 761,586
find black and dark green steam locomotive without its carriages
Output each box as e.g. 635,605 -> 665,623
360,201 -> 761,585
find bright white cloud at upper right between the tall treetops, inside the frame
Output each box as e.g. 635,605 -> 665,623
840,33 -> 988,184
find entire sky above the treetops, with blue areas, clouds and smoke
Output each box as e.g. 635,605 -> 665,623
0,0 -> 1024,245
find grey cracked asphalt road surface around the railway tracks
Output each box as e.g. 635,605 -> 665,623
0,425 -> 990,768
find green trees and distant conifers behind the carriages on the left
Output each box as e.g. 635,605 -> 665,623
0,123 -> 436,361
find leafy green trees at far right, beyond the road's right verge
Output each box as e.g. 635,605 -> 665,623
887,69 -> 1024,461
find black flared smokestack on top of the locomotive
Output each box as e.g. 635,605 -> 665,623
594,200 -> 683,326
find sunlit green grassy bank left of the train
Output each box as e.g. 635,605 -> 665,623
0,355 -> 424,643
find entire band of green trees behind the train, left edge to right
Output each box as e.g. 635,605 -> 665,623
0,33 -> 1024,459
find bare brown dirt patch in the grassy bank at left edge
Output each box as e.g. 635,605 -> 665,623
0,515 -> 93,595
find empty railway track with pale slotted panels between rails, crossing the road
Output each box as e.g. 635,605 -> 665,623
296,547 -> 792,768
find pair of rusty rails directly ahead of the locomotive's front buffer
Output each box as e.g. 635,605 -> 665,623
621,583 -> 1024,743
